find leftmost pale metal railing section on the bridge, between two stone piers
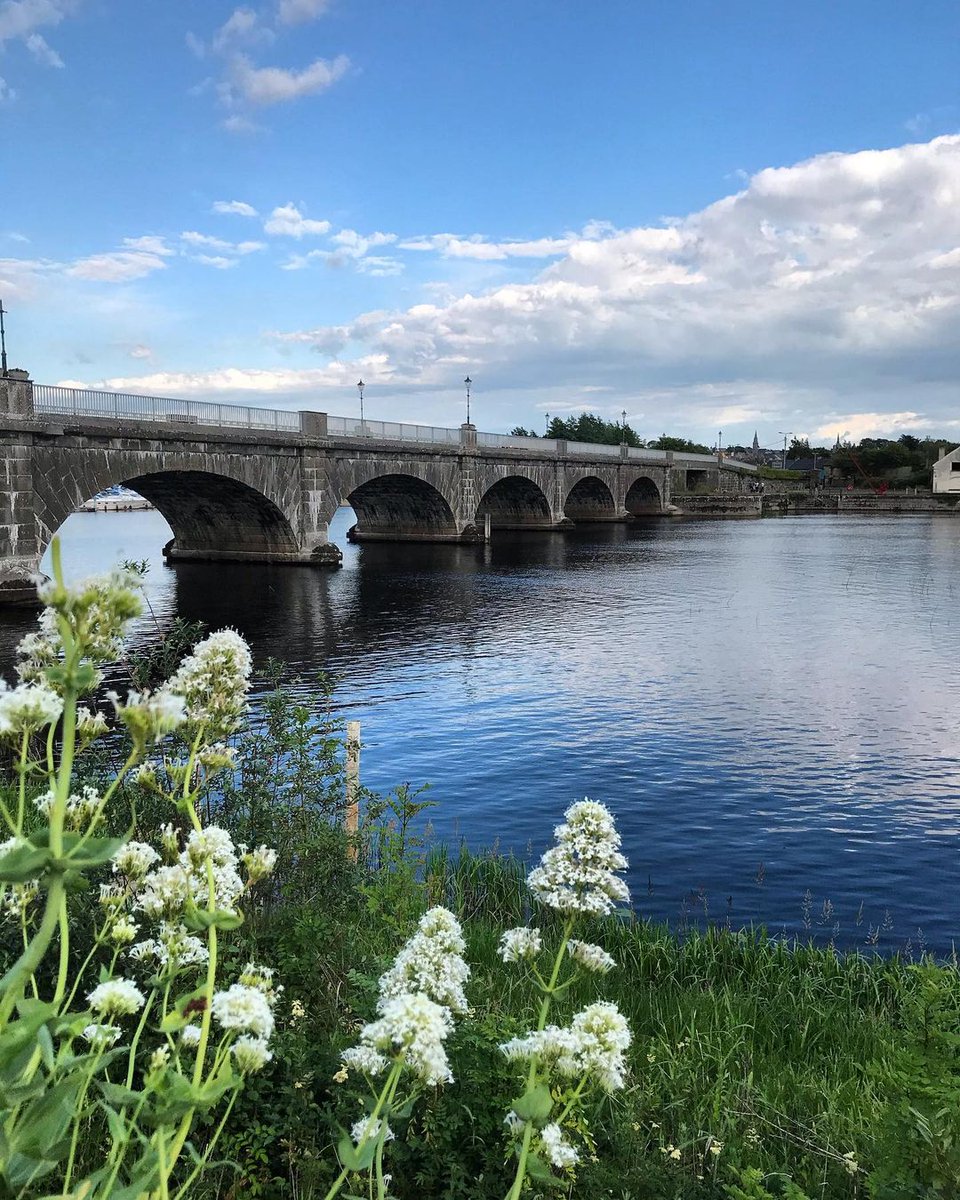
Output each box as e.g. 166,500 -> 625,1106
32,383 -> 300,433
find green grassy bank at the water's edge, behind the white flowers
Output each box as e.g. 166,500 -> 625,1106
204,853 -> 960,1200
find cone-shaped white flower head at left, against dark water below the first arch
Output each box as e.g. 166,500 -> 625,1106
162,629 -> 253,738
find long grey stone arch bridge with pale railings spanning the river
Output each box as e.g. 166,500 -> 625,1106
0,371 -> 750,602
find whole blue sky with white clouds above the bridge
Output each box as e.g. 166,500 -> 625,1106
0,0 -> 960,445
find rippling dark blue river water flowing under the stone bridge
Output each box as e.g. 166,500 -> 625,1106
0,511 -> 960,952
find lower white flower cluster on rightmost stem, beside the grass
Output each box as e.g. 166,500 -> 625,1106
500,1001 -> 631,1092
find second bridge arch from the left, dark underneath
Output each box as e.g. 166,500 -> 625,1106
346,472 -> 460,541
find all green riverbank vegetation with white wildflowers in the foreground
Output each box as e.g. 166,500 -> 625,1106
0,581 -> 960,1200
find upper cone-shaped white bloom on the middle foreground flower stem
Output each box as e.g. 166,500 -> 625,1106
377,907 -> 470,1013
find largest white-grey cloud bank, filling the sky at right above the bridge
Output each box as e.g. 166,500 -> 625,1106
266,136 -> 960,440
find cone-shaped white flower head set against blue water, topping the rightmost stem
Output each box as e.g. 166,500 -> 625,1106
527,800 -> 630,916
